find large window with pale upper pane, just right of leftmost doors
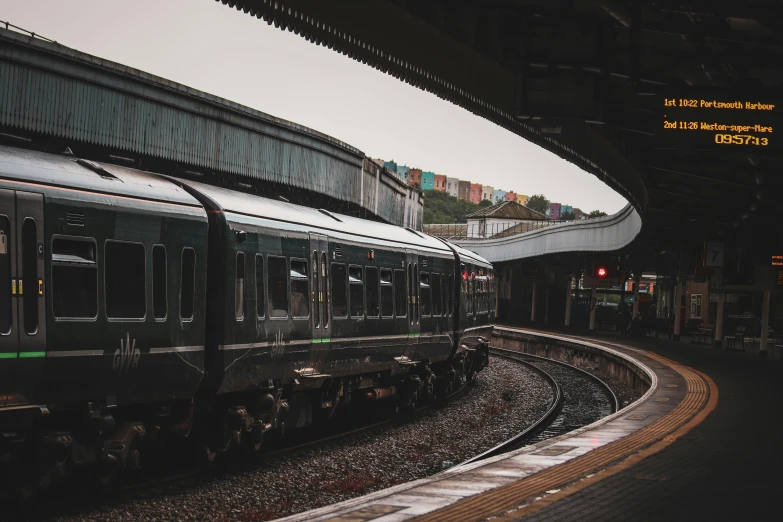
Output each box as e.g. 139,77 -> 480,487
51,238 -> 98,316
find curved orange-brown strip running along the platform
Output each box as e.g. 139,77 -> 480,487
416,332 -> 718,522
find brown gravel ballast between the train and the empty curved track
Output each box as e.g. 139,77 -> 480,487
54,357 -> 553,522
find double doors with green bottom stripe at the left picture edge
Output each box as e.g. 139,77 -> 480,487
0,189 -> 46,406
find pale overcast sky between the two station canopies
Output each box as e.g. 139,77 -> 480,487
0,0 -> 626,213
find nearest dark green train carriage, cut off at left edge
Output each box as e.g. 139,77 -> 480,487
0,147 -> 207,464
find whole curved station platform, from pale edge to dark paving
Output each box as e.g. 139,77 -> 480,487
278,322 -> 783,522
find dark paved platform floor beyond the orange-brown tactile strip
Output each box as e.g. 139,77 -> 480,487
502,329 -> 783,521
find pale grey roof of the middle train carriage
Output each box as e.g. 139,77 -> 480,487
179,180 -> 475,255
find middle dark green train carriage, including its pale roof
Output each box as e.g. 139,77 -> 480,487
173,180 -> 489,447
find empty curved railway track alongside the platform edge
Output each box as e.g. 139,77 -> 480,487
462,347 -> 620,465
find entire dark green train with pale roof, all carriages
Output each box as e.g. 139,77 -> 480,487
0,147 -> 495,484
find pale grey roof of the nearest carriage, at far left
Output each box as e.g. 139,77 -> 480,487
0,145 -> 201,207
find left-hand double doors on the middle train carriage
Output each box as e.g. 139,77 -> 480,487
308,234 -> 332,373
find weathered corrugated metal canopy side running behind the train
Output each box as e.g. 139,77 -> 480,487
0,29 -> 421,225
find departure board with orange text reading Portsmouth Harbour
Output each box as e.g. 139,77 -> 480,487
656,88 -> 783,155
